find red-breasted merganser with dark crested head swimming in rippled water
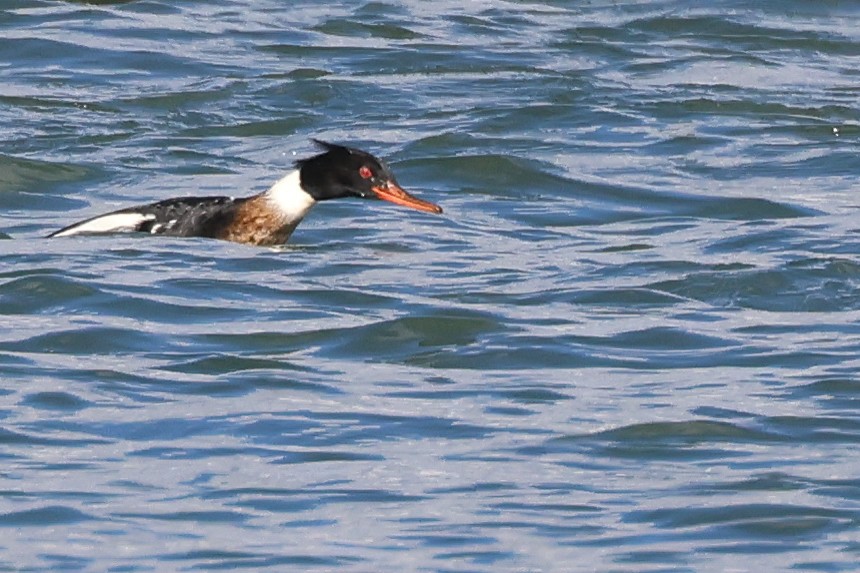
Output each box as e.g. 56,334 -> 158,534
48,139 -> 442,245
